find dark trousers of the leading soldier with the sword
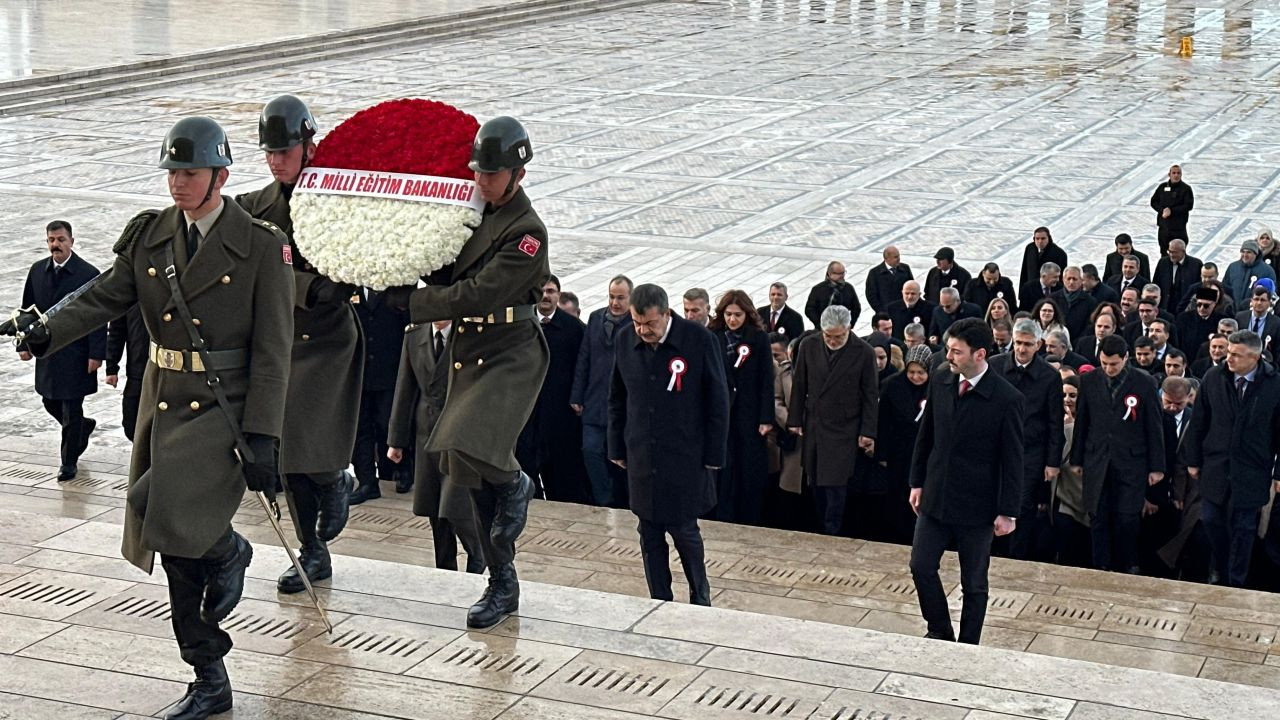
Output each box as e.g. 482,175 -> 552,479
160,527 -> 236,667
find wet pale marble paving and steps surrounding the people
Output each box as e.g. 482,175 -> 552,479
0,0 -> 1280,720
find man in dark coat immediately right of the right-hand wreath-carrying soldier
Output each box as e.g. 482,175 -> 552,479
516,275 -> 591,503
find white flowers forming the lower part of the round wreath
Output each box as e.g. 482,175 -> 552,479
289,192 -> 481,290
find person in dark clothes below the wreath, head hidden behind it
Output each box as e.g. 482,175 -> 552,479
351,287 -> 415,505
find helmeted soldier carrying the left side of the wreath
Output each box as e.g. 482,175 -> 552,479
236,95 -> 365,593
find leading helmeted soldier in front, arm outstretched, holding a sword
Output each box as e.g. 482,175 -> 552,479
0,117 -> 293,720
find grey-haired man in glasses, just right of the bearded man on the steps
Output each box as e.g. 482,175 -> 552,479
989,318 -> 1065,561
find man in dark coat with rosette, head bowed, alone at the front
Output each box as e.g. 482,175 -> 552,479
609,284 -> 728,606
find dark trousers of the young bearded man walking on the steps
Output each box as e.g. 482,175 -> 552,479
911,514 -> 993,644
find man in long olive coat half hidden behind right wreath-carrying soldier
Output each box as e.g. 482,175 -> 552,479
387,320 -> 484,574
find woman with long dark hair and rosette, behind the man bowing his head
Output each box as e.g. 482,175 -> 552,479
709,290 -> 773,525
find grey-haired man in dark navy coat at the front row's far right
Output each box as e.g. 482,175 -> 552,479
1185,331 -> 1280,587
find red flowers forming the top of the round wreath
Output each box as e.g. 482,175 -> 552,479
311,99 -> 480,179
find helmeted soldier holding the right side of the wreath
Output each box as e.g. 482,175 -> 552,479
388,117 -> 550,628
